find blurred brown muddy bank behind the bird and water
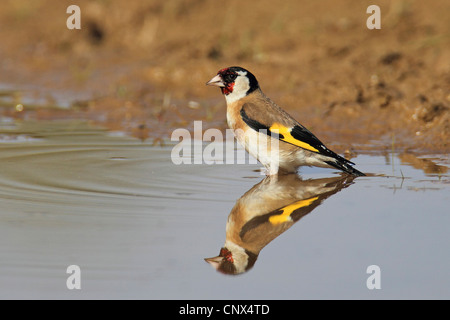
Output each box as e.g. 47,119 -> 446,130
0,0 -> 450,152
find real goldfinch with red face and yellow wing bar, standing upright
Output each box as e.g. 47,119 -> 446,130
206,67 -> 365,176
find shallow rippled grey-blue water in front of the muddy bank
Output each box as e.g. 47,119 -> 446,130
0,119 -> 450,299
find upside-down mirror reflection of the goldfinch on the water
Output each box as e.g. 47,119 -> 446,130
205,174 -> 354,274
